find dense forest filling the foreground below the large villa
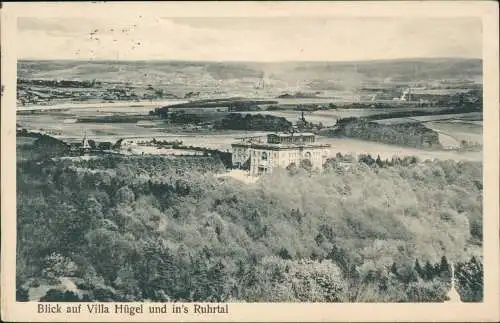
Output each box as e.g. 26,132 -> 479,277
16,139 -> 483,302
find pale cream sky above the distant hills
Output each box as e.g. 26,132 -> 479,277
16,15 -> 482,62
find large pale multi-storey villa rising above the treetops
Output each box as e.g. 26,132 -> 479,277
232,133 -> 330,176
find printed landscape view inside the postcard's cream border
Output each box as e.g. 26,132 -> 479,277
2,3 -> 498,322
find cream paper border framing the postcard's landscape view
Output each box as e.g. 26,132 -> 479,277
1,1 -> 500,322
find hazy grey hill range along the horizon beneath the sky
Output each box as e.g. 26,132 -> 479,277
18,58 -> 482,84
